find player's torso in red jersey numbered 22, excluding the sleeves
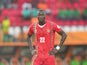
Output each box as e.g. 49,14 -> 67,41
36,22 -> 54,53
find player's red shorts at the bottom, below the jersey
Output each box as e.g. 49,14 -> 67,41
31,55 -> 55,65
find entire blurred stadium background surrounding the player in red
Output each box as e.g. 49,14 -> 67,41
0,0 -> 87,65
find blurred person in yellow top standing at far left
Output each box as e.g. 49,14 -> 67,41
2,16 -> 10,42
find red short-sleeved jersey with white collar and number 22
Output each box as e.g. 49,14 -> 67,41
28,21 -> 61,56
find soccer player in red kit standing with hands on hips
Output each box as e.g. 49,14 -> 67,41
28,10 -> 67,65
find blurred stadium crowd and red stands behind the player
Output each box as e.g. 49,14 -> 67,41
0,0 -> 87,42
